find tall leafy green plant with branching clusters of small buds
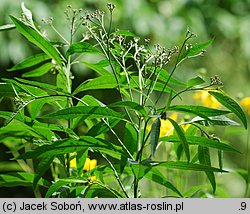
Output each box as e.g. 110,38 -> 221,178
0,4 -> 247,198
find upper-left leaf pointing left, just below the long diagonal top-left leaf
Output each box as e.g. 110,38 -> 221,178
7,53 -> 51,71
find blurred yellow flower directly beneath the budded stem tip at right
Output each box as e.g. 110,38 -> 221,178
194,91 -> 221,108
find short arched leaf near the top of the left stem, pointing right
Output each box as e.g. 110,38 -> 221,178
66,42 -> 101,58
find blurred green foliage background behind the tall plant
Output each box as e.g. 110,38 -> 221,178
0,0 -> 250,197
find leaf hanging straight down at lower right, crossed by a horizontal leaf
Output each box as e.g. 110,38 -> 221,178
198,146 -> 216,192
